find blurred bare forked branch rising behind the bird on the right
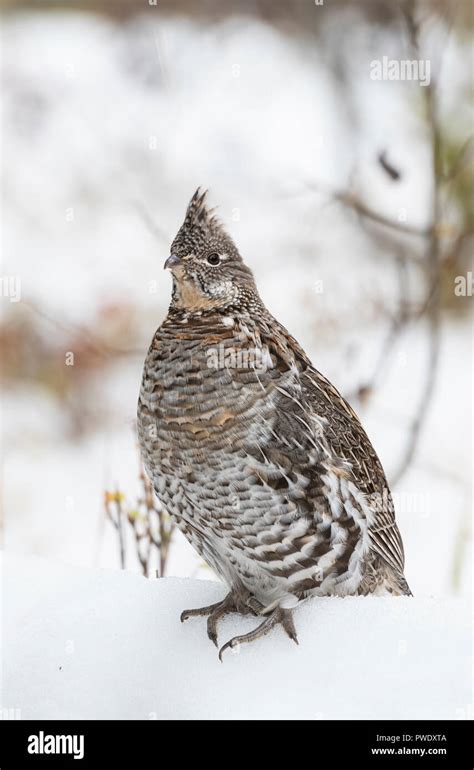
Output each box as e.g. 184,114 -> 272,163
309,0 -> 474,485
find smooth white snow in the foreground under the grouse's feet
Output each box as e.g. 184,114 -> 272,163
2,556 -> 472,719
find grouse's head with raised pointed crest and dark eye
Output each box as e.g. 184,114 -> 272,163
165,188 -> 258,311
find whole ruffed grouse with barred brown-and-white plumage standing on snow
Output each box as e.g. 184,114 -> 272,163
138,190 -> 410,657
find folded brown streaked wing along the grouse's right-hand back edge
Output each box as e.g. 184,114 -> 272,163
260,319 -> 404,574
